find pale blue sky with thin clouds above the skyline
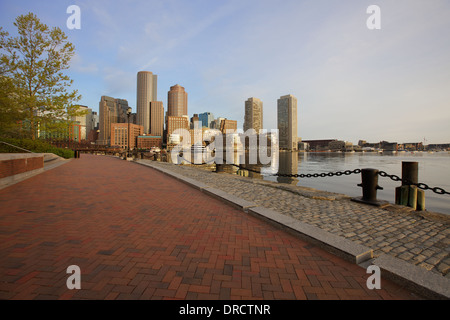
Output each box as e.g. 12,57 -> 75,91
0,0 -> 450,143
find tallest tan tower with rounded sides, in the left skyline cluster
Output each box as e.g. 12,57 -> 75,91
136,71 -> 158,134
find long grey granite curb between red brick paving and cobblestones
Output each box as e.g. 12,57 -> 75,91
134,160 -> 450,299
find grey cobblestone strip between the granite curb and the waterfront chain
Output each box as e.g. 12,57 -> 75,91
140,160 -> 450,278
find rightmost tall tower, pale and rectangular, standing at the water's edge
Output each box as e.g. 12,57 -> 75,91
278,94 -> 298,150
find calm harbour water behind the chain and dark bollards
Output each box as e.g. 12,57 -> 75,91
264,152 -> 450,214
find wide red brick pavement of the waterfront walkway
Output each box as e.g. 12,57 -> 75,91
0,154 -> 422,300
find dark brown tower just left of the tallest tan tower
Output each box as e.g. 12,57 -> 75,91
97,96 -> 128,145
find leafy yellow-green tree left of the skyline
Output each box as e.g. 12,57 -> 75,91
0,13 -> 82,140
